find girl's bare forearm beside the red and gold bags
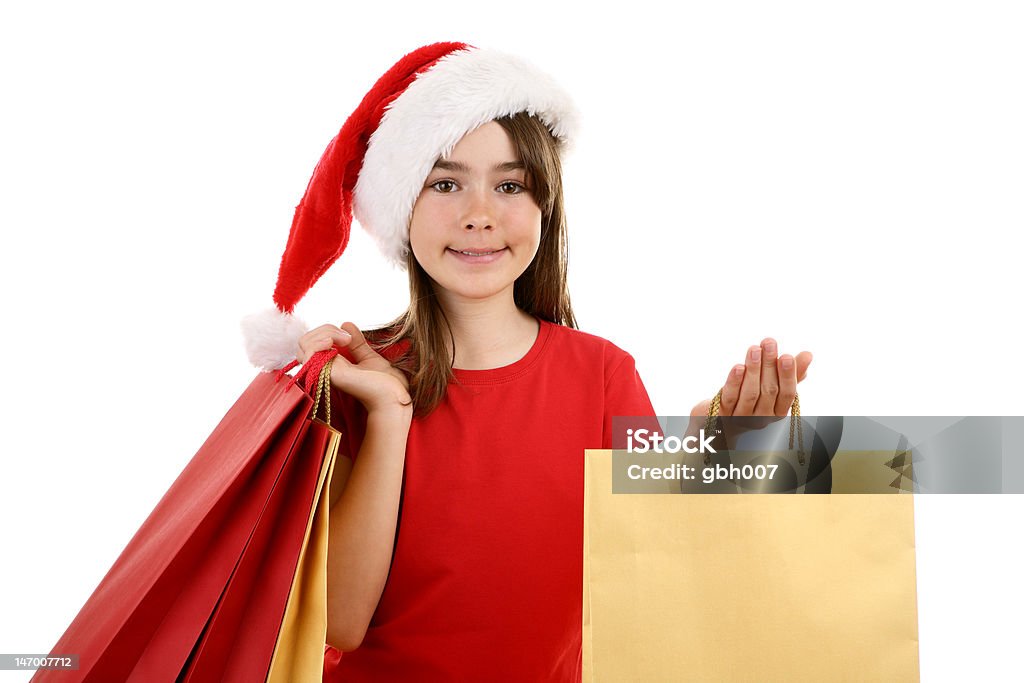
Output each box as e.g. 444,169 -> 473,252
327,403 -> 413,651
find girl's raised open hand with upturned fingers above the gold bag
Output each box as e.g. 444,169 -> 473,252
690,337 -> 813,418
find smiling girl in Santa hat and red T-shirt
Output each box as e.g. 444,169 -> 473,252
241,43 -> 810,681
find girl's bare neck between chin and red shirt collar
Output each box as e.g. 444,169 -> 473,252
436,300 -> 540,370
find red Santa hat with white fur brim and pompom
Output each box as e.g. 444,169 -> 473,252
242,43 -> 577,370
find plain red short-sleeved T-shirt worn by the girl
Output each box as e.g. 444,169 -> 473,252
324,322 -> 654,682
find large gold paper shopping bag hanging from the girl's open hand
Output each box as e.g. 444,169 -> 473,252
583,451 -> 919,683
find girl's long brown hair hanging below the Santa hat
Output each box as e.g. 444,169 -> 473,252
367,112 -> 577,416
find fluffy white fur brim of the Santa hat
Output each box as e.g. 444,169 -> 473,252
353,48 -> 578,268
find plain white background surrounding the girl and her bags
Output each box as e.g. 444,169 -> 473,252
0,0 -> 1024,681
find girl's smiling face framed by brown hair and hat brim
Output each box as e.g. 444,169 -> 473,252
409,121 -> 541,302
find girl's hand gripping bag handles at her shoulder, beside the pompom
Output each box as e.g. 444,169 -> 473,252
296,323 -> 413,413
